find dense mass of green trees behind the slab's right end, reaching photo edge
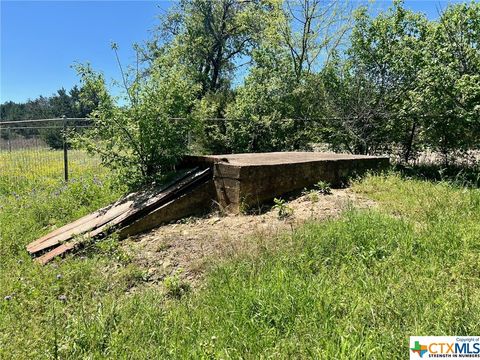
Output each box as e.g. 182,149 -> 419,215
326,2 -> 480,161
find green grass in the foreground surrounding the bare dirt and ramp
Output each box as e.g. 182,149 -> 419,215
0,160 -> 480,359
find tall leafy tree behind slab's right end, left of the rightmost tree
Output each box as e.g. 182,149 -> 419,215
330,2 -> 427,161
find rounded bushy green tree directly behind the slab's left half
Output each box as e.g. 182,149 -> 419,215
226,48 -> 300,152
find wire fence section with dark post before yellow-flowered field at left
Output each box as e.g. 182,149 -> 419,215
0,117 -> 99,187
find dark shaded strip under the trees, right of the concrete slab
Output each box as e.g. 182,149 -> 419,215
394,163 -> 480,188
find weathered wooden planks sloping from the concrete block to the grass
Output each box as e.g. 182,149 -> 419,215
27,168 -> 213,264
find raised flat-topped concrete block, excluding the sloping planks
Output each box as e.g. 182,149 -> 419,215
185,152 -> 389,213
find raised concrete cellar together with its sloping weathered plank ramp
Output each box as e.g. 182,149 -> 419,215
27,152 -> 389,264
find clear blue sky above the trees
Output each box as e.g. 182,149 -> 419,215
0,0 -> 464,103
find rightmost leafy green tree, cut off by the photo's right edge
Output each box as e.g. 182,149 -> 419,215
417,2 -> 480,163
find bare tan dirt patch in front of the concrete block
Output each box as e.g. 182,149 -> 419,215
122,189 -> 375,285
